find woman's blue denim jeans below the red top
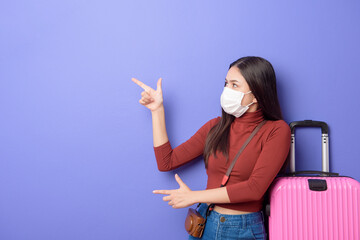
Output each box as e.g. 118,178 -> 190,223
189,203 -> 266,240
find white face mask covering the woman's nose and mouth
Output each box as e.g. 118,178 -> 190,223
220,87 -> 254,117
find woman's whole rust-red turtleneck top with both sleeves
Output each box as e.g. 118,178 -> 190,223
154,110 -> 290,212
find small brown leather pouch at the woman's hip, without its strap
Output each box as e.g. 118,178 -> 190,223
185,208 -> 206,238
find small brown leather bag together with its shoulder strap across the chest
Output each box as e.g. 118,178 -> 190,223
185,120 -> 266,238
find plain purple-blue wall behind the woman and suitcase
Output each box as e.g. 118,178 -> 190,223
0,0 -> 360,240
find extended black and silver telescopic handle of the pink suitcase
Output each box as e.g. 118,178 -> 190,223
290,120 -> 329,173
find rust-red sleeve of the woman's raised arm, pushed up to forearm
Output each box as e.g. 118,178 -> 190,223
154,117 -> 220,171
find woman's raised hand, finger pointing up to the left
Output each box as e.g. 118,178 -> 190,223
131,78 -> 163,112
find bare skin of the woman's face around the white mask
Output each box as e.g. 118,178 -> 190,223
225,66 -> 257,109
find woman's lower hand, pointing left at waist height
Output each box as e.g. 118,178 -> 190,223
153,174 -> 196,208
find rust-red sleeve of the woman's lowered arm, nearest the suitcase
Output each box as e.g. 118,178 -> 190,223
226,121 -> 290,203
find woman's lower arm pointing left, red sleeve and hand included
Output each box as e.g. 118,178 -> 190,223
154,121 -> 290,208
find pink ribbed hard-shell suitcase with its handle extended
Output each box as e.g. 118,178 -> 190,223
267,120 -> 360,240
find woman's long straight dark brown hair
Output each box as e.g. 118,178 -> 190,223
203,57 -> 282,167
